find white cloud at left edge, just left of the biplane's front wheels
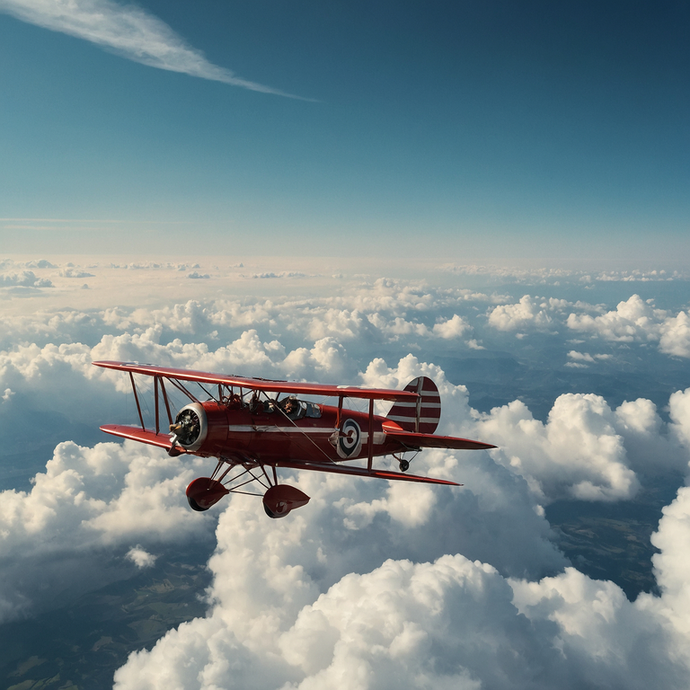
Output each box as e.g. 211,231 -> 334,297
0,441 -> 212,622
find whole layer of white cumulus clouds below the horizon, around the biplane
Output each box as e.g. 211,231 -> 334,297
0,255 -> 690,690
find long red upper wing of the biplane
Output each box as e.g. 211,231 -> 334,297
92,361 -> 419,400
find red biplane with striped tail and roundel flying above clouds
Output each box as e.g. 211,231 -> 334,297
93,361 -> 495,518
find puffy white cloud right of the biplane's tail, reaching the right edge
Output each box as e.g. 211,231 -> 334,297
477,389 -> 690,502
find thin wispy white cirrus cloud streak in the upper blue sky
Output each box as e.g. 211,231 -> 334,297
0,0 -> 309,100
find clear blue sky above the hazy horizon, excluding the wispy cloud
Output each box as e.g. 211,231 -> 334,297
0,0 -> 690,264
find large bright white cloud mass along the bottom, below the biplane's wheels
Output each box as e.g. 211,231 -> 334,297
114,478 -> 690,690
